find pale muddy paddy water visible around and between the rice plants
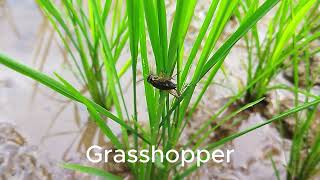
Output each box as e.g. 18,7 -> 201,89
0,0 -> 316,180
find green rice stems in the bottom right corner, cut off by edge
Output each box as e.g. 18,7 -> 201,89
287,104 -> 320,180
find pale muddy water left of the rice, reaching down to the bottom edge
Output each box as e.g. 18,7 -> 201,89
0,0 -> 96,179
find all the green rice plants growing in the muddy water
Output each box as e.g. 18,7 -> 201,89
0,0 -> 320,179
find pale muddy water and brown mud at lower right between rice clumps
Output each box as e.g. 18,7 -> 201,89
185,102 -> 290,179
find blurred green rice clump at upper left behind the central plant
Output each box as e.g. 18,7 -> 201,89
36,0 -> 131,109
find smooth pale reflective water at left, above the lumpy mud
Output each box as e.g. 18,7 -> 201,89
0,0 -> 96,162
